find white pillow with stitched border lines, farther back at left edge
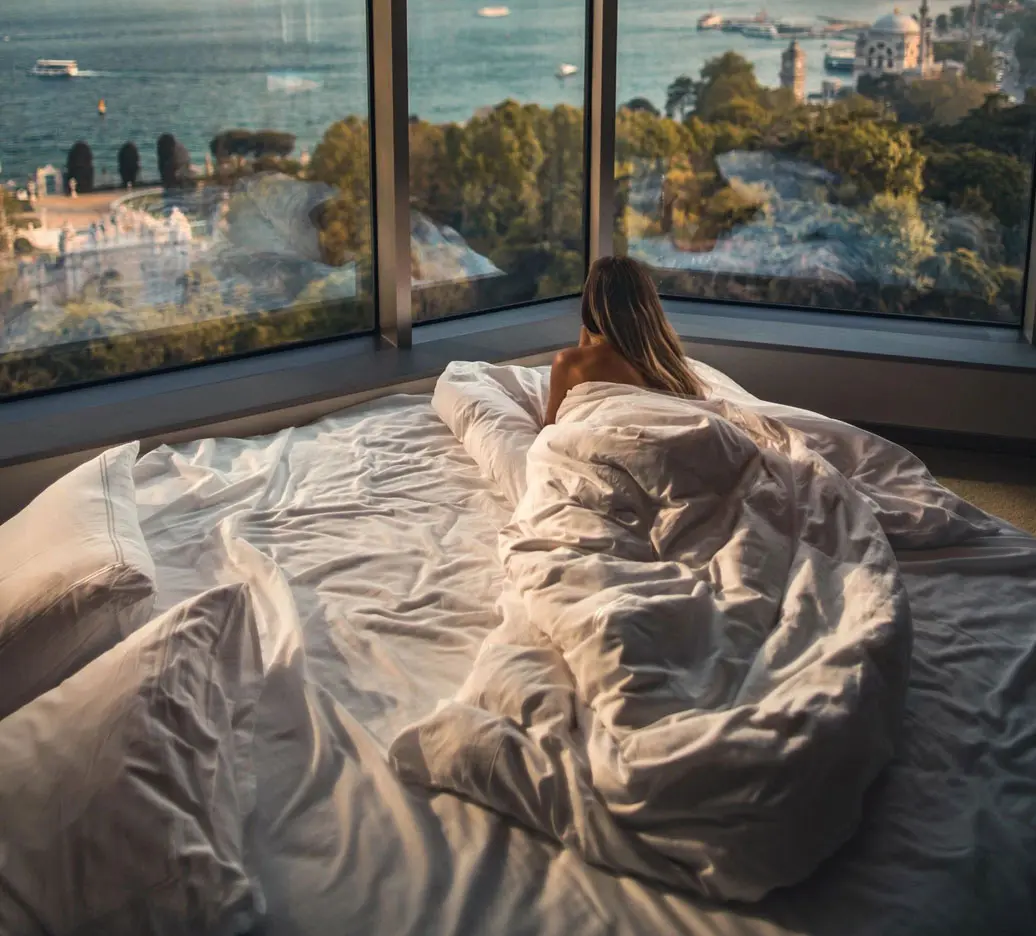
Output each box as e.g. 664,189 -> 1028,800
0,443 -> 154,718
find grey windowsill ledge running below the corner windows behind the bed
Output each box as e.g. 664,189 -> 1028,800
0,299 -> 1036,467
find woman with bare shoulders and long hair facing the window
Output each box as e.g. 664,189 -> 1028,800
545,257 -> 704,426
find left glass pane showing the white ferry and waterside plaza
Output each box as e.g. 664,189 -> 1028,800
0,0 -> 374,397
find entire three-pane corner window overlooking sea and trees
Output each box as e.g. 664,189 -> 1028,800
0,0 -> 1036,399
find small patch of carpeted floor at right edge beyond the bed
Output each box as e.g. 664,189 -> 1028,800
908,446 -> 1036,535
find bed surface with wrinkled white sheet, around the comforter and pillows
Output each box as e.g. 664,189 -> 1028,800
136,389 -> 1036,936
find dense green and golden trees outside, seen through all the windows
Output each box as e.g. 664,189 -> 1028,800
0,39 -> 1036,395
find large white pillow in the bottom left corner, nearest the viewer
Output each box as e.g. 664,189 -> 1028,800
0,585 -> 262,936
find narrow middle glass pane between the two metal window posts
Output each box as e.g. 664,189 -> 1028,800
408,0 -> 586,321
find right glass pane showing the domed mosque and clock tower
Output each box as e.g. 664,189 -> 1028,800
616,0 -> 1036,323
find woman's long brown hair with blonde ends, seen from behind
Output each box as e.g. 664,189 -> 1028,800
582,257 -> 704,397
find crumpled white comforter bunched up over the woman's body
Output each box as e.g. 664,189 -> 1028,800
390,364 -> 992,901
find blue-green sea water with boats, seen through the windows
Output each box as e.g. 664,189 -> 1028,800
0,0 -> 953,181
